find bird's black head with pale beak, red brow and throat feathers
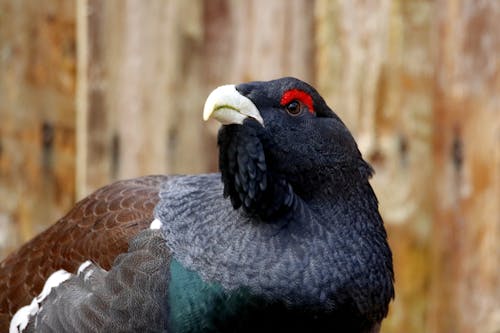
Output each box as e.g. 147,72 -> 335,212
203,77 -> 371,219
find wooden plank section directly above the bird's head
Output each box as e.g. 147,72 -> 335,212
205,0 -> 314,85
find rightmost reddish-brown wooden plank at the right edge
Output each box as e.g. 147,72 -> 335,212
427,0 -> 500,333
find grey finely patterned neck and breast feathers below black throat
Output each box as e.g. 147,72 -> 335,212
155,174 -> 350,306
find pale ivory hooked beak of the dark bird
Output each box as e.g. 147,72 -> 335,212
203,84 -> 264,126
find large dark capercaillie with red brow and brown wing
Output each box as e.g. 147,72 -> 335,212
0,77 -> 395,333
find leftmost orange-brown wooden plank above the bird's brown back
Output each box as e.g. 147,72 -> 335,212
0,0 -> 76,257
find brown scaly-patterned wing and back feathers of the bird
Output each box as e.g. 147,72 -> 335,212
0,176 -> 167,332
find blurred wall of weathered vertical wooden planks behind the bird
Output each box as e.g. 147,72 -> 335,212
0,0 -> 500,333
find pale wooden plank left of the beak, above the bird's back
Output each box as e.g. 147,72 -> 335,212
83,0 -> 208,193
